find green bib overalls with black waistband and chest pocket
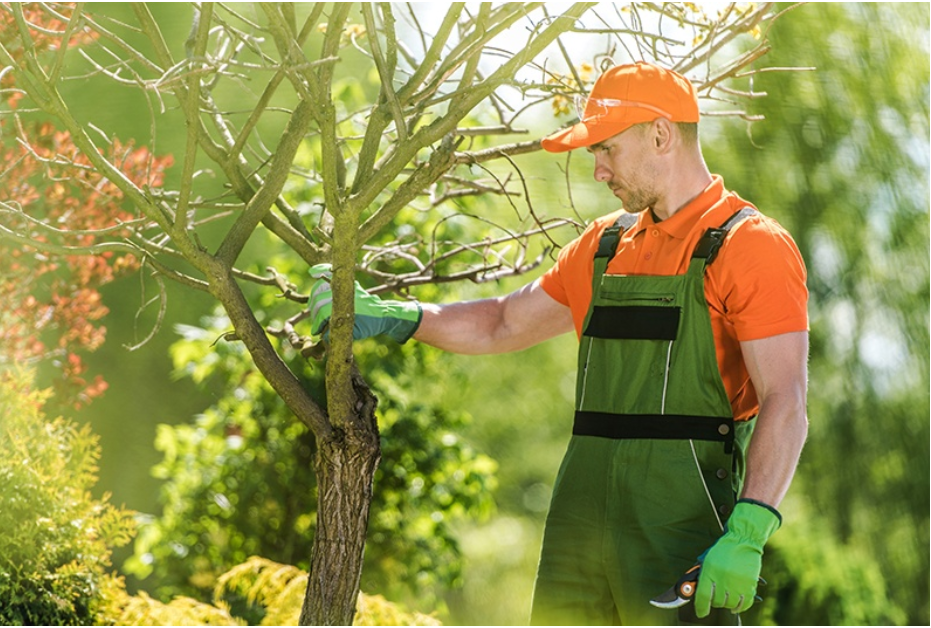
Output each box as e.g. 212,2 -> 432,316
531,208 -> 754,625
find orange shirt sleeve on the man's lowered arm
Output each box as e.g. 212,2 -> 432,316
710,216 -> 808,341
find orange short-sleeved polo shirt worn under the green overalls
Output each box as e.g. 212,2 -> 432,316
540,175 -> 808,420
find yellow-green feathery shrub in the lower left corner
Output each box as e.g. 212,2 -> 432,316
0,370 -> 133,626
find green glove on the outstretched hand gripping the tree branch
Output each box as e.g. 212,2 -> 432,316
307,264 -> 423,343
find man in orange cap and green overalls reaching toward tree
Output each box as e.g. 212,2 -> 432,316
311,63 -> 808,624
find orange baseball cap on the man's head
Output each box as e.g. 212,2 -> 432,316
541,61 -> 698,153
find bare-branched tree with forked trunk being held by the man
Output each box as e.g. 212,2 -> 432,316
0,3 -> 792,624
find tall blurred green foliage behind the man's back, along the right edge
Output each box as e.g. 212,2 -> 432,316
705,3 -> 931,624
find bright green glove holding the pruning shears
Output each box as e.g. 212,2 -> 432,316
695,499 -> 782,617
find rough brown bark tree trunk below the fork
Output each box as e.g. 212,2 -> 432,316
300,368 -> 381,626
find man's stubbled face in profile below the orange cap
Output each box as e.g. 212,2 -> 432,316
588,125 -> 659,213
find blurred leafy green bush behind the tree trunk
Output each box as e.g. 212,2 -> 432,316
127,316 -> 495,620
